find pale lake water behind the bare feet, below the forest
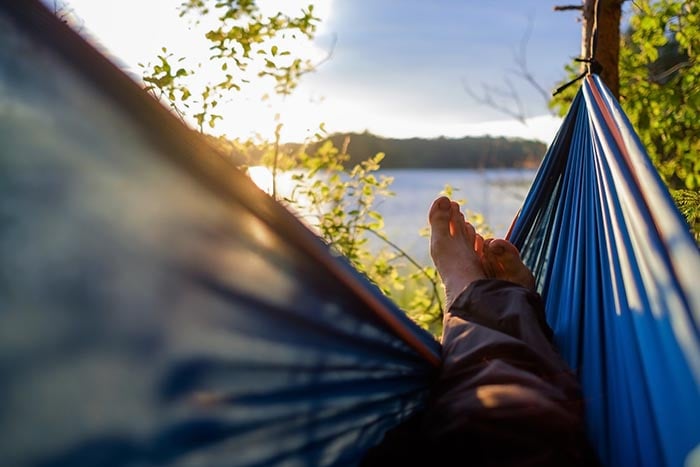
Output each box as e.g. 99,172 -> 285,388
377,169 -> 536,262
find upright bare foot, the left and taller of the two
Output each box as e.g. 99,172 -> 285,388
428,196 -> 486,309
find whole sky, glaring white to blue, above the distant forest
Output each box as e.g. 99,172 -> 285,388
56,0 -> 592,143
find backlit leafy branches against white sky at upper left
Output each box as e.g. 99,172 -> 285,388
139,0 -> 318,132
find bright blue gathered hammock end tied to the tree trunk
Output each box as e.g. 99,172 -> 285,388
510,76 -> 700,467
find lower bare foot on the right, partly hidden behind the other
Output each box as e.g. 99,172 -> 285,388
482,238 -> 535,290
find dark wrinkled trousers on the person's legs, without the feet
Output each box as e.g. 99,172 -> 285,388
424,280 -> 596,466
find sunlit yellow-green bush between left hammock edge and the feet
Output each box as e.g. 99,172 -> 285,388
249,133 -> 443,334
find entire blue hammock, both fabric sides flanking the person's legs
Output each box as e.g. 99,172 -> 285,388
0,1 -> 700,467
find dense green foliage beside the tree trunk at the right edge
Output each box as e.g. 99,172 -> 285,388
553,0 -> 700,238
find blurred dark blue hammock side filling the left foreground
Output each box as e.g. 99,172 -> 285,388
0,1 -> 439,467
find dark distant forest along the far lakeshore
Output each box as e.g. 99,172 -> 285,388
309,132 -> 547,169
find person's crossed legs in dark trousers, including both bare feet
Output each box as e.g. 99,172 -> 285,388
425,198 -> 593,465
